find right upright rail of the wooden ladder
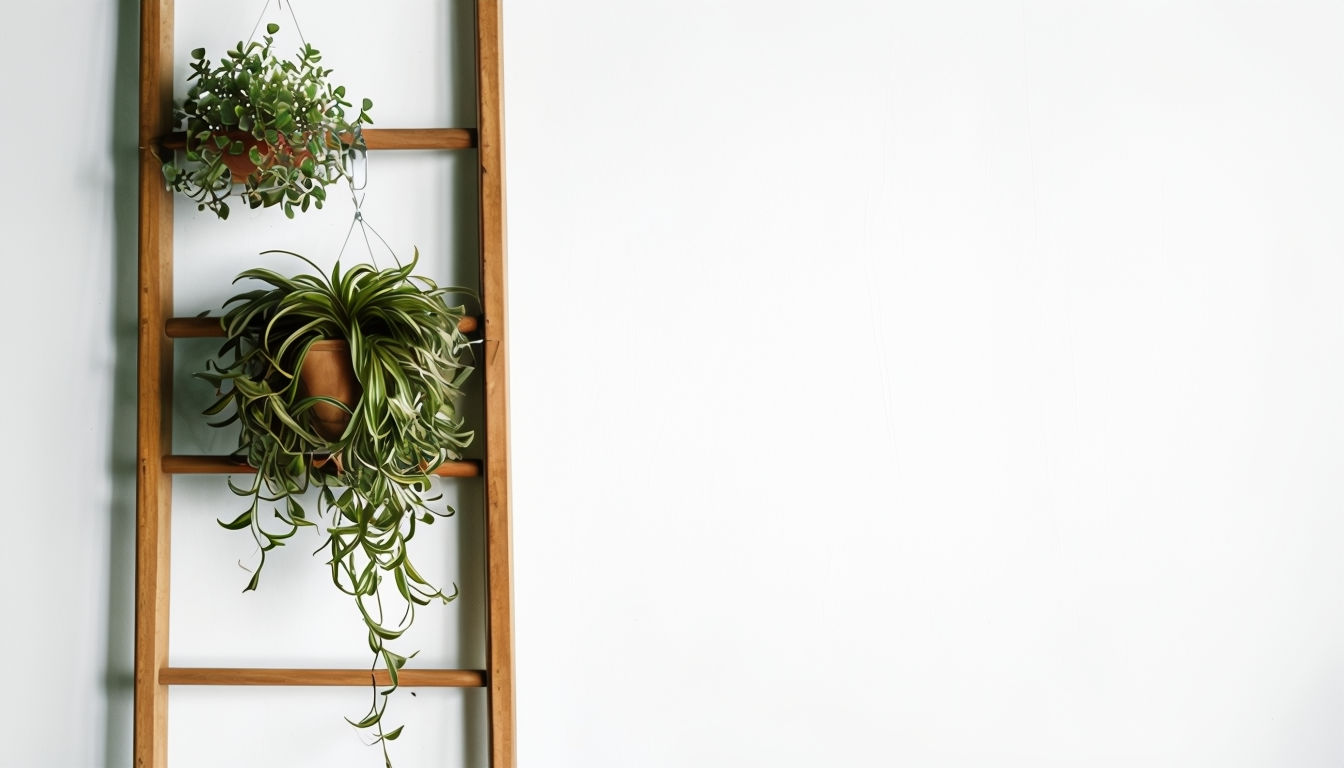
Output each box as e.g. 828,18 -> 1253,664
476,0 -> 517,768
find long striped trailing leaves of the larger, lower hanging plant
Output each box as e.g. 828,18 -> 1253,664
196,252 -> 472,757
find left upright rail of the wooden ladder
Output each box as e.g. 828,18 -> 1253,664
132,0 -> 173,768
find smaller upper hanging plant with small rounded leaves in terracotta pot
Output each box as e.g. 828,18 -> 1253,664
163,24 -> 374,219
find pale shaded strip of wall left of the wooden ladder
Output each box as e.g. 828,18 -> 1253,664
0,0 -> 136,768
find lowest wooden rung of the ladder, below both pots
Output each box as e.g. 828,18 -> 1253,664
159,667 -> 485,689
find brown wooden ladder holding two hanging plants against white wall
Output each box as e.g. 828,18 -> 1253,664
134,0 -> 516,768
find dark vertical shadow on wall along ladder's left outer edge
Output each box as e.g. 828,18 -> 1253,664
103,0 -> 140,768
